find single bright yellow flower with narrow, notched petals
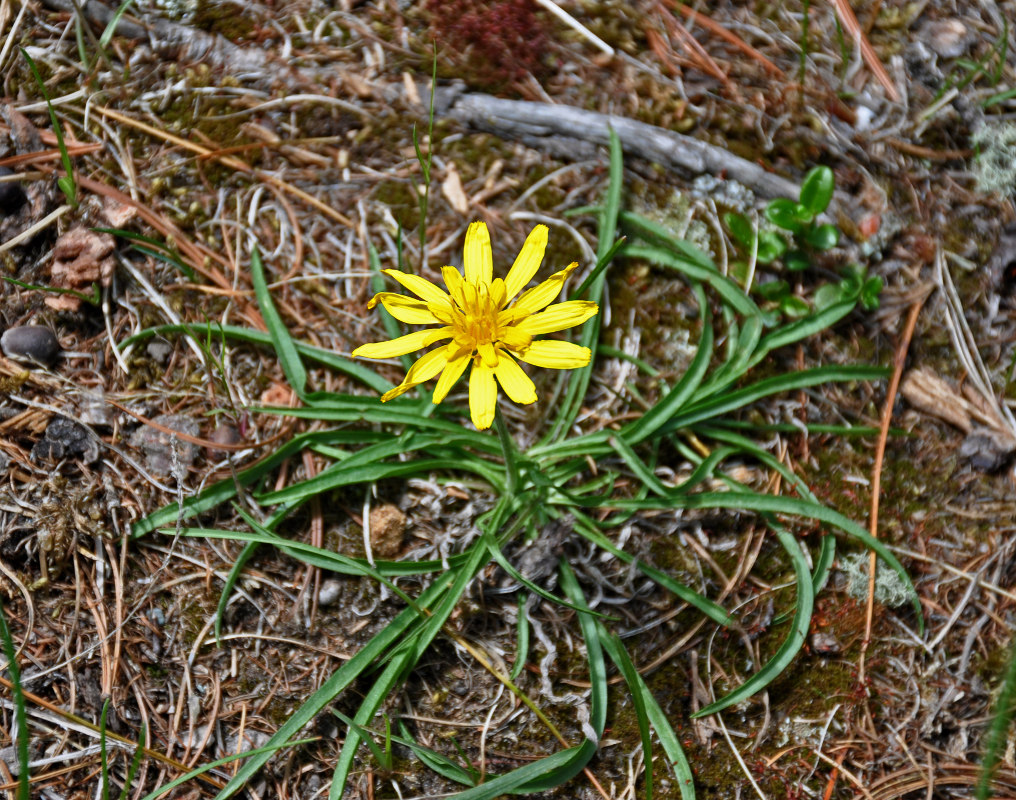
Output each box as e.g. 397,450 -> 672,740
353,223 -> 599,430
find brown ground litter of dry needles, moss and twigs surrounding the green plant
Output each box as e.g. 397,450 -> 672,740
0,0 -> 1016,800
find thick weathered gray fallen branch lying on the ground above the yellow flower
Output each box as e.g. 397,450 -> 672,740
434,87 -> 800,197
